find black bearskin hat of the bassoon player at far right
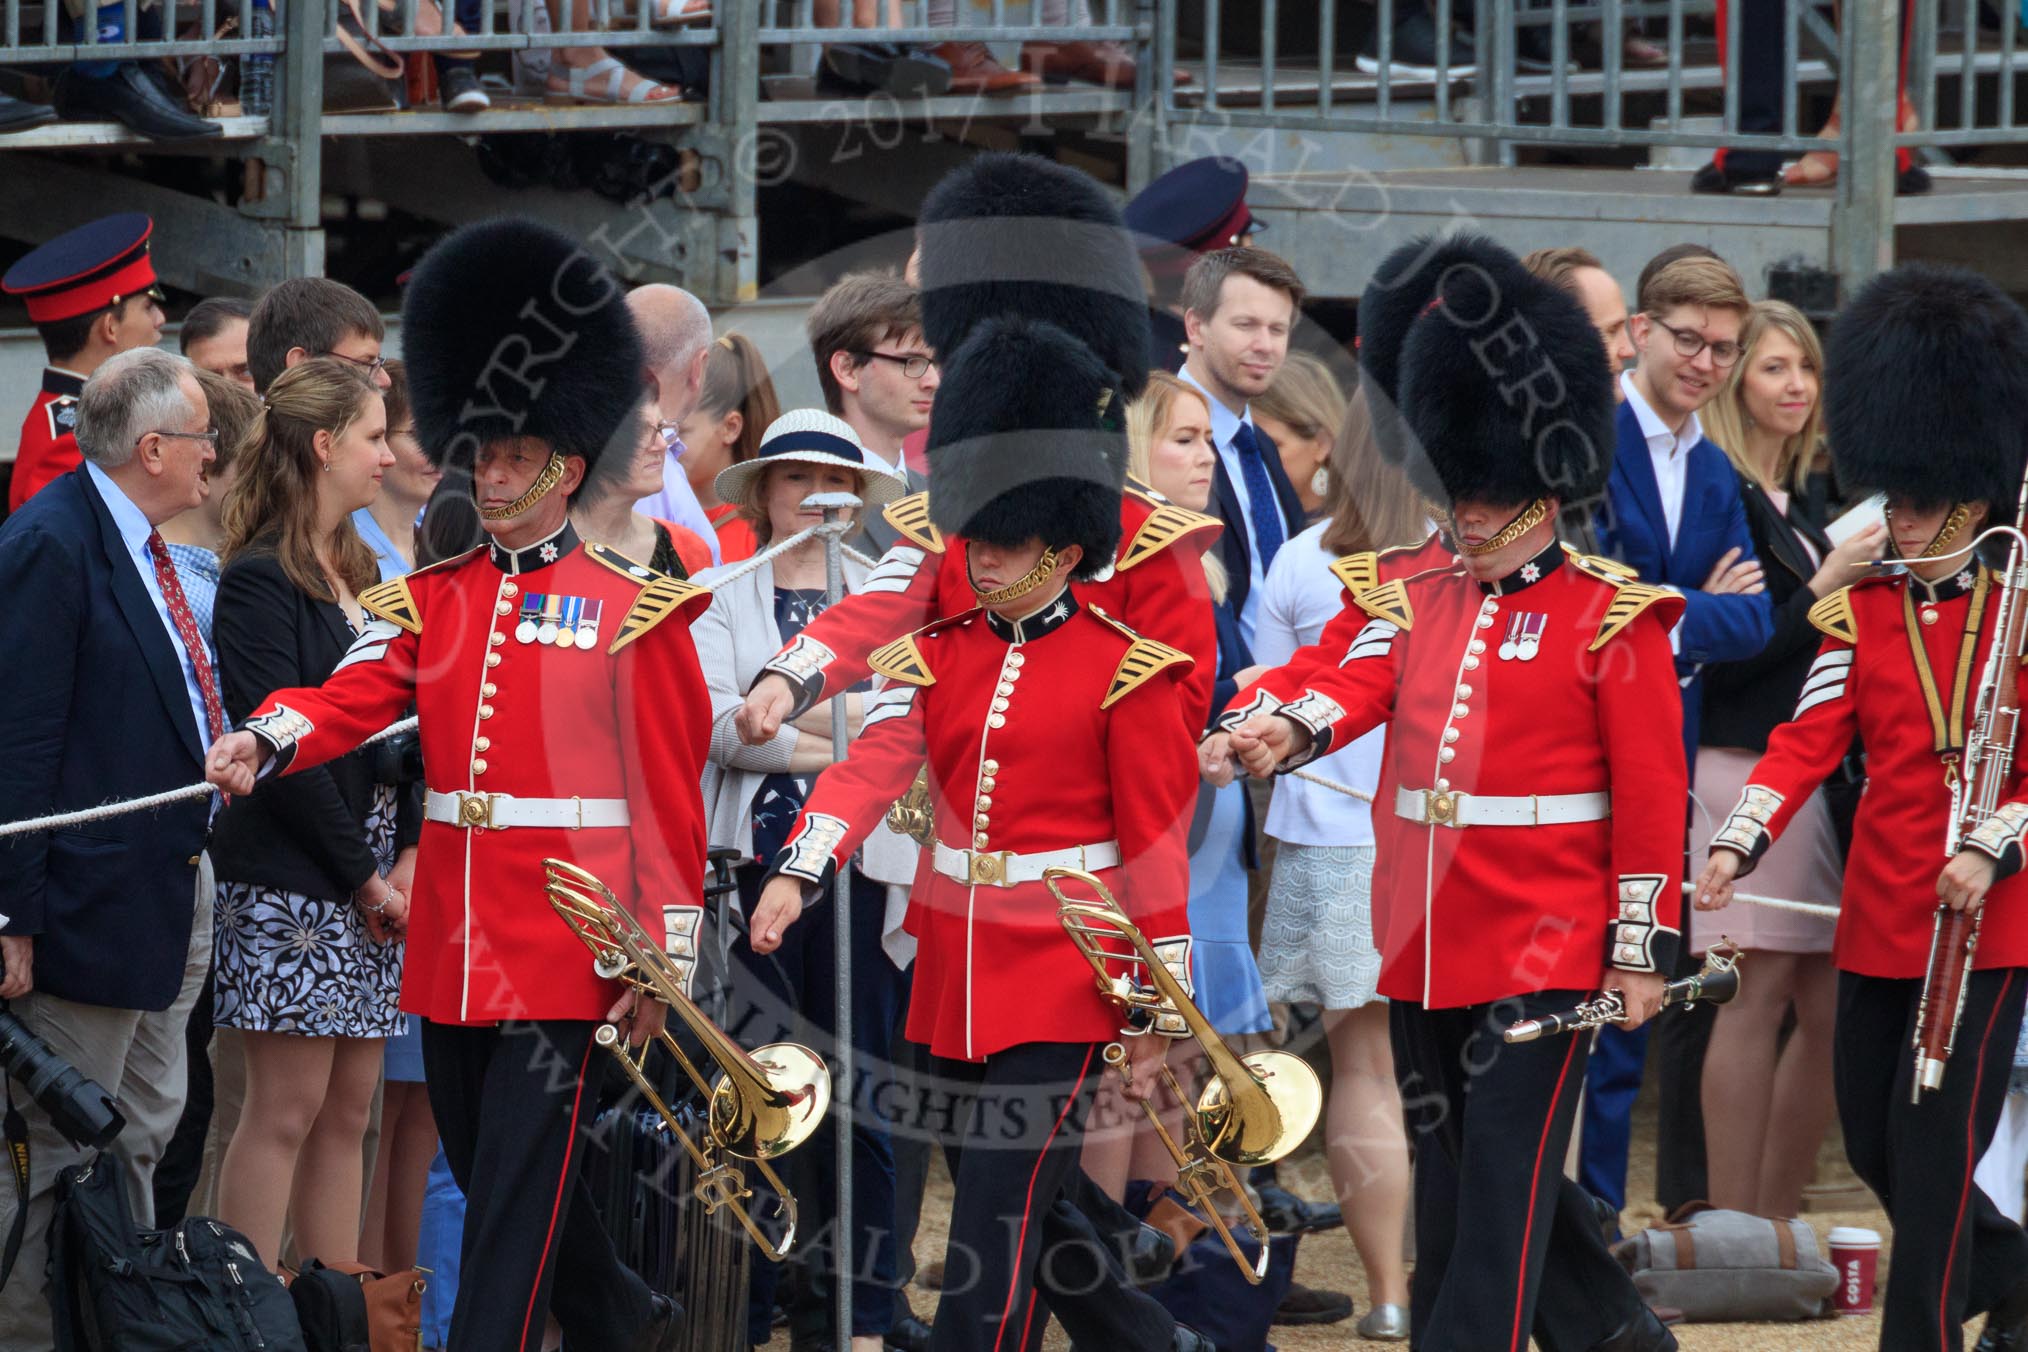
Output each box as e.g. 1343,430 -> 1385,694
1823,264 -> 2028,521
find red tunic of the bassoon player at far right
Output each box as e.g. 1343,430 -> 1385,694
1712,570 -> 2028,977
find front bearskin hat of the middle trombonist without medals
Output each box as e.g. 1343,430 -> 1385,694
929,314 -> 1128,578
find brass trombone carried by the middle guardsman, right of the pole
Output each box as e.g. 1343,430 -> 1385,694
1042,868 -> 1324,1285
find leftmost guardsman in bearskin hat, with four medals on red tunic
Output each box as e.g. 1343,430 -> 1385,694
207,221 -> 712,1352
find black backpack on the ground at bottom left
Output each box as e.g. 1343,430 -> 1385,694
49,1151 -> 306,1352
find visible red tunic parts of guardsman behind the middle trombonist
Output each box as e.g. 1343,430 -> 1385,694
767,482 -> 1223,730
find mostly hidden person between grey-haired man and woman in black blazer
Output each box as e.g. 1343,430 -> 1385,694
154,367 -> 260,1228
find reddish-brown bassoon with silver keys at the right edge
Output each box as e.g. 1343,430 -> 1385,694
1908,478 -> 2028,1103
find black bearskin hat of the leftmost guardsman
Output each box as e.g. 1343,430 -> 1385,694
402,219 -> 643,478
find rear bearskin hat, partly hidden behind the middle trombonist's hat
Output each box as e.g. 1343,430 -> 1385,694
917,152 -> 1148,397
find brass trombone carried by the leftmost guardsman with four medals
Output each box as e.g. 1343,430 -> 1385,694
541,859 -> 831,1263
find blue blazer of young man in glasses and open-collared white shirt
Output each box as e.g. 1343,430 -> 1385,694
1598,403 -> 1775,760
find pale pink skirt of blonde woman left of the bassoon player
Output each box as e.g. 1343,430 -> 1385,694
1689,746 -> 1845,953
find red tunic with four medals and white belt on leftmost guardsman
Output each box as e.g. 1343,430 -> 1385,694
247,527 -> 710,1024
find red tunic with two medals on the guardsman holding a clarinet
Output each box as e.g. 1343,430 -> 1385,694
1221,545 -> 1689,1007
